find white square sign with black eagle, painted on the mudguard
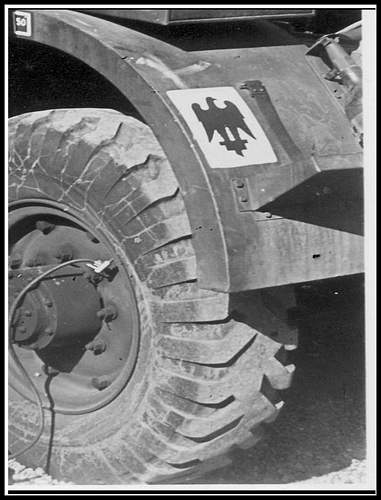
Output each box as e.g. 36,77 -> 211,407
167,87 -> 278,168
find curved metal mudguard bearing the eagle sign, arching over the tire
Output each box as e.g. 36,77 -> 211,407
10,10 -> 363,292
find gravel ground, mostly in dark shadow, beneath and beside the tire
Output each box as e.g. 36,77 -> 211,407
10,280 -> 368,489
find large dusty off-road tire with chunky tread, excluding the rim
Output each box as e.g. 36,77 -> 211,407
9,109 -> 295,484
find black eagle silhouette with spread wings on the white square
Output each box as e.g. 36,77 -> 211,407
192,97 -> 256,156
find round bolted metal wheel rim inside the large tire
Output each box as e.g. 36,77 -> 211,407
9,200 -> 139,414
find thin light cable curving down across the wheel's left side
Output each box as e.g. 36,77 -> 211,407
8,259 -> 95,460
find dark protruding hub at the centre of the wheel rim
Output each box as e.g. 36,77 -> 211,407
9,266 -> 102,349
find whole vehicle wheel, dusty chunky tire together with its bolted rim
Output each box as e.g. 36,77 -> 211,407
9,109 -> 295,484
